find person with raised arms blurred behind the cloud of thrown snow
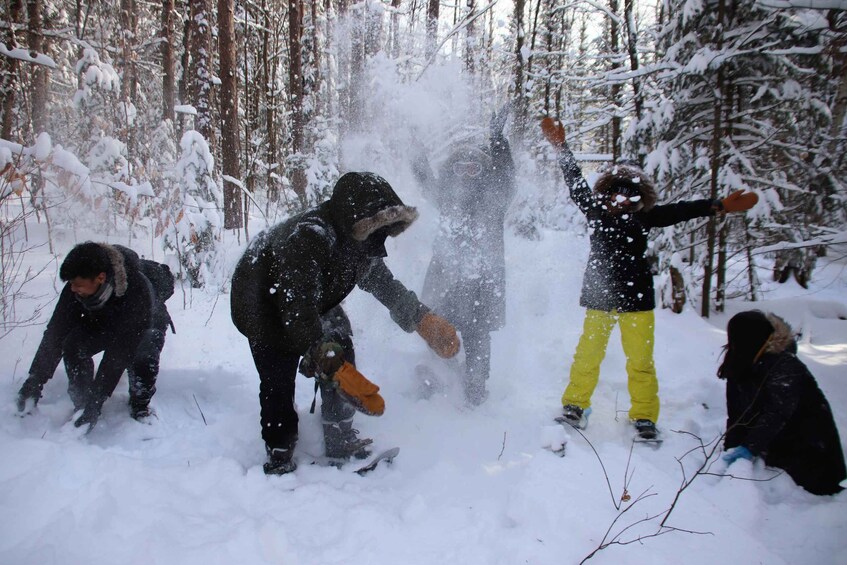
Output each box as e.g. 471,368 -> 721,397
412,108 -> 515,405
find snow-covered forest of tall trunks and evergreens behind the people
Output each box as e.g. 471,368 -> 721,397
0,0 -> 847,326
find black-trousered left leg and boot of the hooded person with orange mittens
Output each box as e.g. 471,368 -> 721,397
249,339 -> 300,475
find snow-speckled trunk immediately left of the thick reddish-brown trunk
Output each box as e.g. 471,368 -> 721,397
189,0 -> 216,148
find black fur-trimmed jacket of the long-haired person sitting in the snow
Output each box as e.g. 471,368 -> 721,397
724,318 -> 847,494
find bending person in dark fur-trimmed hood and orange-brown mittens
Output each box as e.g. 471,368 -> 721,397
231,173 -> 460,474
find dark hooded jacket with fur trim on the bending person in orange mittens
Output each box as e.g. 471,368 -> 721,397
231,173 -> 429,354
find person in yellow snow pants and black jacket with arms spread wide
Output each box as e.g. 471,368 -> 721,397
541,117 -> 758,440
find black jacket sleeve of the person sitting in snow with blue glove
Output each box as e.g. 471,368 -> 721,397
740,356 -> 806,455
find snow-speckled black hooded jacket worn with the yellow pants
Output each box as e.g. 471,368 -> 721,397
559,147 -> 715,312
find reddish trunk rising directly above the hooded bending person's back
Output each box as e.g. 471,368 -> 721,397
288,0 -> 306,204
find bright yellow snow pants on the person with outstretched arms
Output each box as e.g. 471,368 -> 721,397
562,310 -> 659,423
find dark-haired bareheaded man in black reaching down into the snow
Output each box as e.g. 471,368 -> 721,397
17,241 -> 173,431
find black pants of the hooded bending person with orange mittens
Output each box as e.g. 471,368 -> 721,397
248,306 -> 356,449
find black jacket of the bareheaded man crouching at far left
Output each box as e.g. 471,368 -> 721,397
29,244 -> 154,402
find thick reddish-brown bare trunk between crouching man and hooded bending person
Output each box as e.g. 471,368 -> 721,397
218,0 -> 244,230
